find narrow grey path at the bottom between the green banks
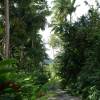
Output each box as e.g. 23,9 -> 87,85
48,90 -> 81,100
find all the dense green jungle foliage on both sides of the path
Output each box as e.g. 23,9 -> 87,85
0,0 -> 100,100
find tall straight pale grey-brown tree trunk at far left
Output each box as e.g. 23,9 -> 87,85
4,0 -> 10,58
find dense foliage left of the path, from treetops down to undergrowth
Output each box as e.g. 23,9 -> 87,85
0,0 -> 49,100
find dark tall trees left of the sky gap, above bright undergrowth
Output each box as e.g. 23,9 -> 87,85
0,0 -> 49,71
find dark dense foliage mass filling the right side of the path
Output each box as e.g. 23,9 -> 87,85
52,0 -> 100,100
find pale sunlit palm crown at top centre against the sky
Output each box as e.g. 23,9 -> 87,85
53,0 -> 77,23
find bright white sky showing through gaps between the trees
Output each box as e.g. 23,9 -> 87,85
40,0 -> 98,59
